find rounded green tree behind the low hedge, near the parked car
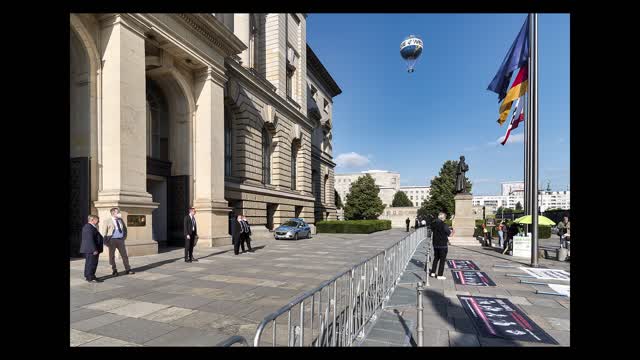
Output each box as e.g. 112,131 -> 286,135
344,174 -> 385,220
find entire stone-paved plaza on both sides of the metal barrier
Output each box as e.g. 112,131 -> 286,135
70,229 -> 570,346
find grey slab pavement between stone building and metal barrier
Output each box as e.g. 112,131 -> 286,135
69,229 -> 410,346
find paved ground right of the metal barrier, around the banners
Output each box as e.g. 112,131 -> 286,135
359,239 -> 570,346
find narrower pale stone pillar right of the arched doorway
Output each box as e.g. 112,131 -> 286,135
193,67 -> 231,247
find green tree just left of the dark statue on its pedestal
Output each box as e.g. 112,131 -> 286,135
418,160 -> 471,218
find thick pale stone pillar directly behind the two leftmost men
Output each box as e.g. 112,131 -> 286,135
95,14 -> 158,256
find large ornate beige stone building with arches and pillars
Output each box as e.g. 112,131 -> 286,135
70,13 -> 341,256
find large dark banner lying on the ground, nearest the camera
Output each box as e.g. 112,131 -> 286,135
458,295 -> 558,345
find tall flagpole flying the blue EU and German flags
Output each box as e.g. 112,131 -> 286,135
529,13 -> 538,267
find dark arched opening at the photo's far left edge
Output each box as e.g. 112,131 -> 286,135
69,28 -> 92,257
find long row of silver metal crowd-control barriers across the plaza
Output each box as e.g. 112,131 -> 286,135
253,228 -> 427,347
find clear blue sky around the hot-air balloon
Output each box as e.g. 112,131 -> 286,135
307,14 -> 569,195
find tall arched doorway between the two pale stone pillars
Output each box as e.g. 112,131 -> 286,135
146,68 -> 193,246
